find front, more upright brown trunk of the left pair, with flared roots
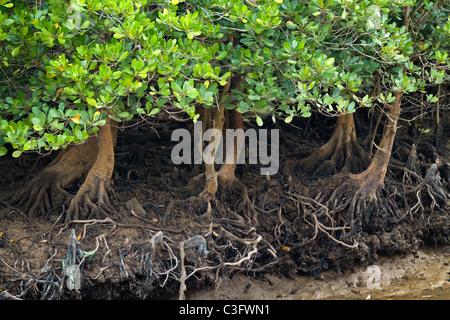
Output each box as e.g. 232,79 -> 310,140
66,119 -> 117,221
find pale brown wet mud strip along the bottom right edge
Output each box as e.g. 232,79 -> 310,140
187,246 -> 450,300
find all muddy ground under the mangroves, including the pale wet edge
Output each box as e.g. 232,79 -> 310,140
0,115 -> 450,300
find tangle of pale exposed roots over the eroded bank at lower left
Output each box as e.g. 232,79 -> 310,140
0,209 -> 278,299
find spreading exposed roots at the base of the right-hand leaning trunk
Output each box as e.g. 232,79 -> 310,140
286,166 -> 400,249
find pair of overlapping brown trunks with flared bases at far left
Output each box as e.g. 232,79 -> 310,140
9,120 -> 117,220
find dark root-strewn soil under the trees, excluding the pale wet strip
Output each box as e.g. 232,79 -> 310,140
0,113 -> 450,299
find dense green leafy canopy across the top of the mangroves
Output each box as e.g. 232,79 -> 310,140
0,0 -> 450,157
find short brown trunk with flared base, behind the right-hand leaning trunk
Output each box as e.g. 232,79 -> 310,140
300,114 -> 366,175
